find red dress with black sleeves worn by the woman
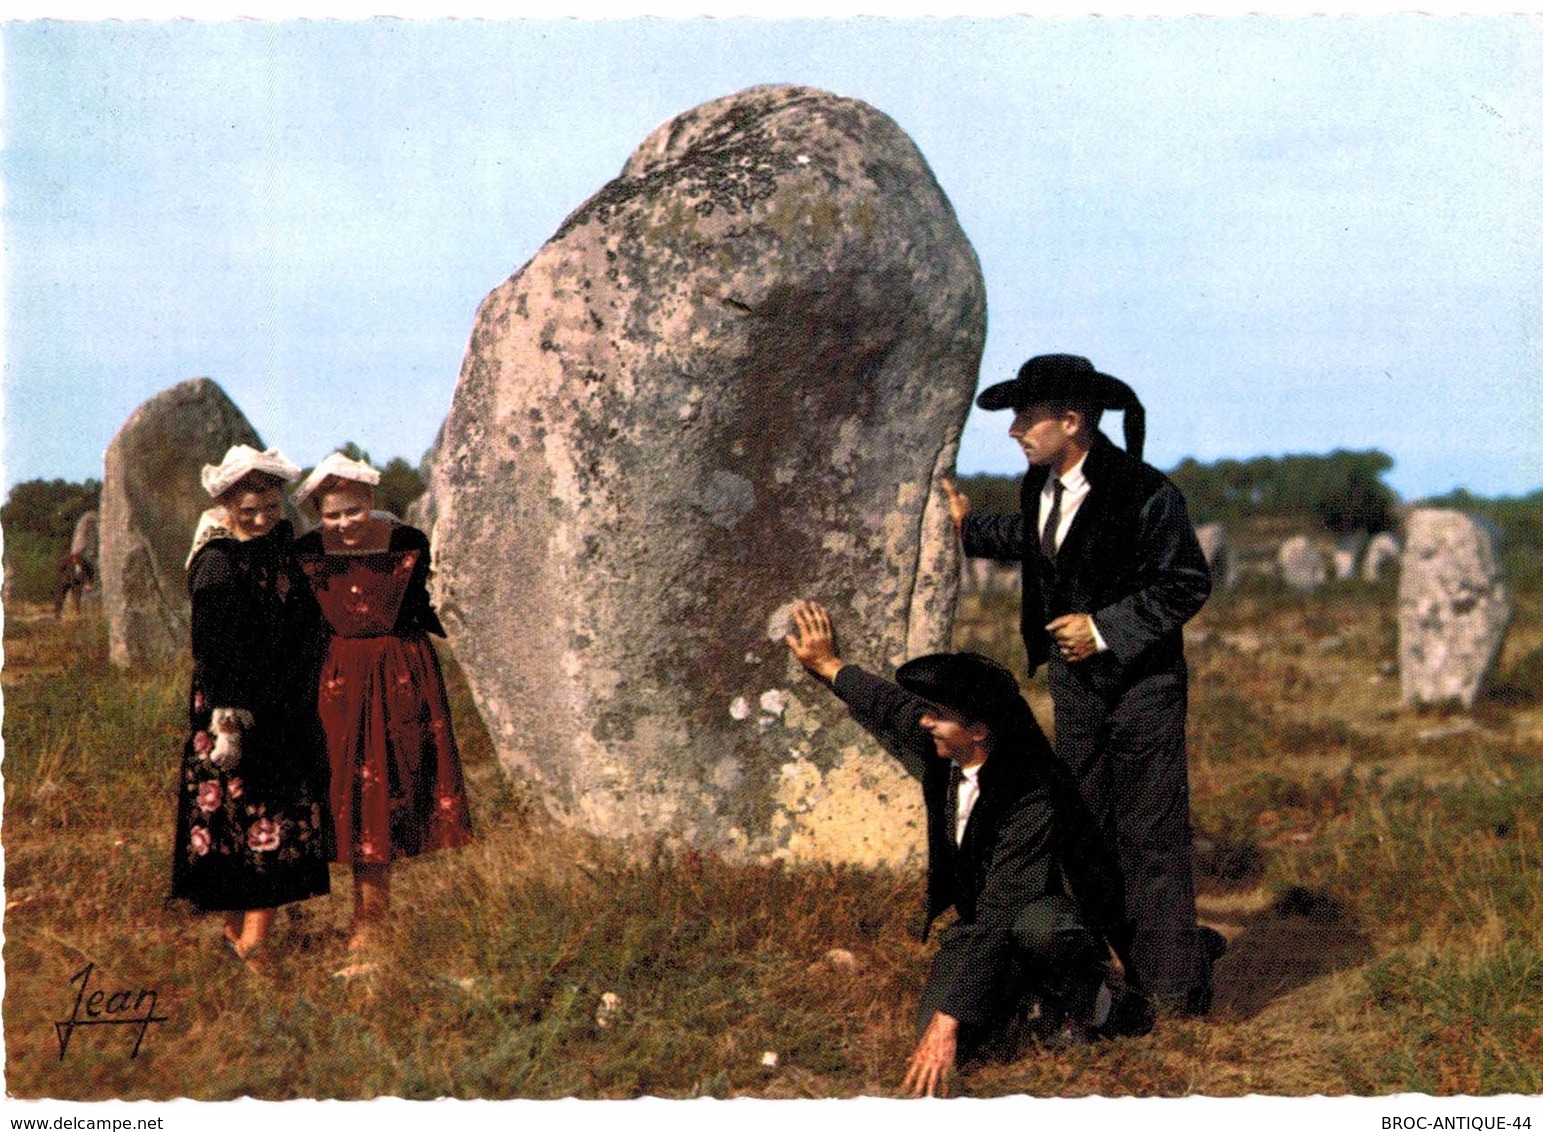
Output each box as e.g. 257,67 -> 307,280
296,526 -> 472,865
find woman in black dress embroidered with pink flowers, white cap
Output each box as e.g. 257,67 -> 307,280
171,444 -> 332,959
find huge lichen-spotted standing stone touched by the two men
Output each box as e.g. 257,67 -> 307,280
420,86 -> 986,864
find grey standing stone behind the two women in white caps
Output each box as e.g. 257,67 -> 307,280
100,378 -> 262,668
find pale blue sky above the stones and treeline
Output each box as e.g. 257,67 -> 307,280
0,15 -> 1543,497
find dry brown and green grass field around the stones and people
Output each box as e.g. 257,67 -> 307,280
3,586 -> 1543,1100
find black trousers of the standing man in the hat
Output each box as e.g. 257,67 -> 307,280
1049,657 -> 1213,1012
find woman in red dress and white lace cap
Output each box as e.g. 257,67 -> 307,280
295,452 -> 472,952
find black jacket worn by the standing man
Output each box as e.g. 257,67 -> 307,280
963,432 -> 1211,691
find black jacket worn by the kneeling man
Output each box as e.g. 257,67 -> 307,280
833,665 -> 1120,1021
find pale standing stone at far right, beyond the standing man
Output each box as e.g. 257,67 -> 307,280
1398,507 -> 1511,708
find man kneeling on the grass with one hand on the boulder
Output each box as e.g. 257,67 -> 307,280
787,601 -> 1151,1097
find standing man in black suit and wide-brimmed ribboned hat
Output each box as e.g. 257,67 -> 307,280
944,353 -> 1225,1015
